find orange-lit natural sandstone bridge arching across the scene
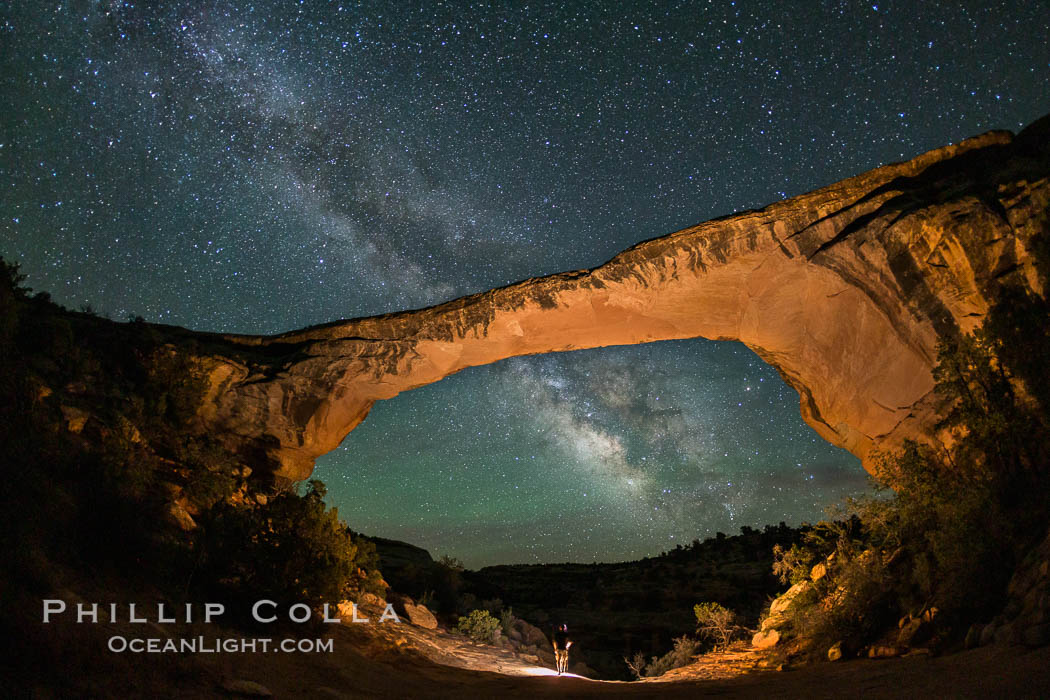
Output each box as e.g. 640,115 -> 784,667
191,118 -> 1050,480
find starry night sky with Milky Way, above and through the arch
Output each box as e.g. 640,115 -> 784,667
0,0 -> 1050,567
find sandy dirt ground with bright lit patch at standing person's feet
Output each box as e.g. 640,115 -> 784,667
221,604 -> 1050,699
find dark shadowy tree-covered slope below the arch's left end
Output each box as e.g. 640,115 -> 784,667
0,260 -> 394,650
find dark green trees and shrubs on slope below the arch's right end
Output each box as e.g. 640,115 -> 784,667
774,288 -> 1050,653
